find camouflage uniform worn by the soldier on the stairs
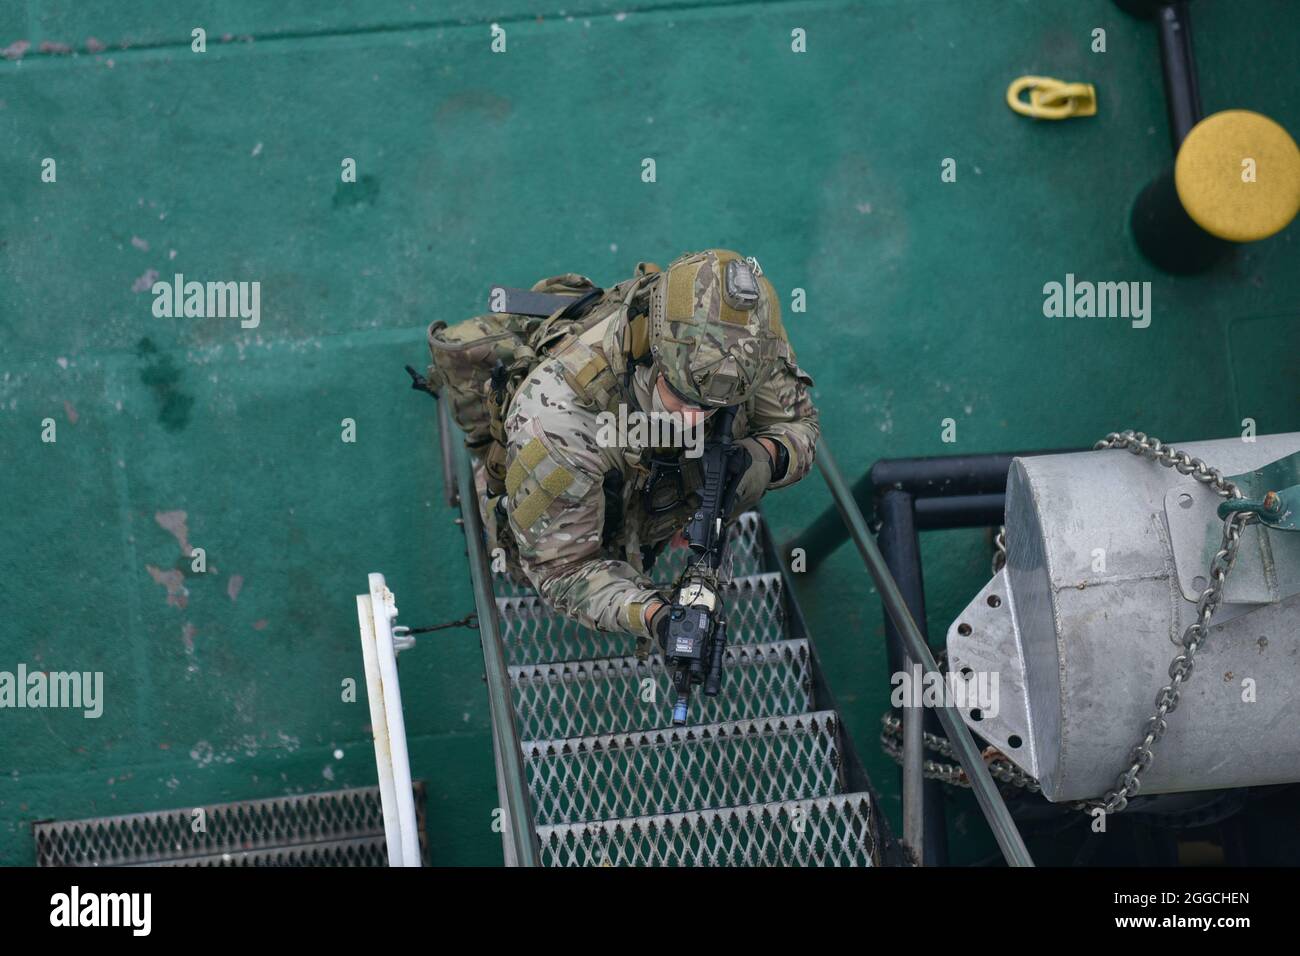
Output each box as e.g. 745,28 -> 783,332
485,251 -> 819,641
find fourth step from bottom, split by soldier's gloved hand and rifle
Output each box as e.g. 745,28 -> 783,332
497,572 -> 785,663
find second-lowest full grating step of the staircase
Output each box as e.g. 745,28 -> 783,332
524,710 -> 840,823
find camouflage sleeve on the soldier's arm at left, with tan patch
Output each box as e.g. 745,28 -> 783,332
506,367 -> 659,637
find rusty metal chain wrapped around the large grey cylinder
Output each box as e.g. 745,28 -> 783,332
880,431 -> 1257,813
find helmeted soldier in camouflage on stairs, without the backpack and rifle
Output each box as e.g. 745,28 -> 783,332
485,250 -> 819,657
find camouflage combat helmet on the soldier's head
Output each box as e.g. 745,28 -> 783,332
649,248 -> 785,407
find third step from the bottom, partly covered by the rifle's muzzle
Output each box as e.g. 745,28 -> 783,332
510,640 -> 813,740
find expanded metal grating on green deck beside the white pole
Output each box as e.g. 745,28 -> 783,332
35,783 -> 428,866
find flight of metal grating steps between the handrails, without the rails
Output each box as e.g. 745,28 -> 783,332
482,512 -> 900,866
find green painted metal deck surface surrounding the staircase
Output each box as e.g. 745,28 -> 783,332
0,0 -> 1300,864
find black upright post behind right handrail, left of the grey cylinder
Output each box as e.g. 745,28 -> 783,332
876,490 -> 948,866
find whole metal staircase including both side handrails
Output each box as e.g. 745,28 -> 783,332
441,398 -> 1032,866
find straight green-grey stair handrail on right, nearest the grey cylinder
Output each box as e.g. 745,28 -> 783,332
816,438 -> 1034,866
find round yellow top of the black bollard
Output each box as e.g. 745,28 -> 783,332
1174,109 -> 1300,242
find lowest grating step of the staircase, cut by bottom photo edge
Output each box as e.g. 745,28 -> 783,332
537,793 -> 875,866
